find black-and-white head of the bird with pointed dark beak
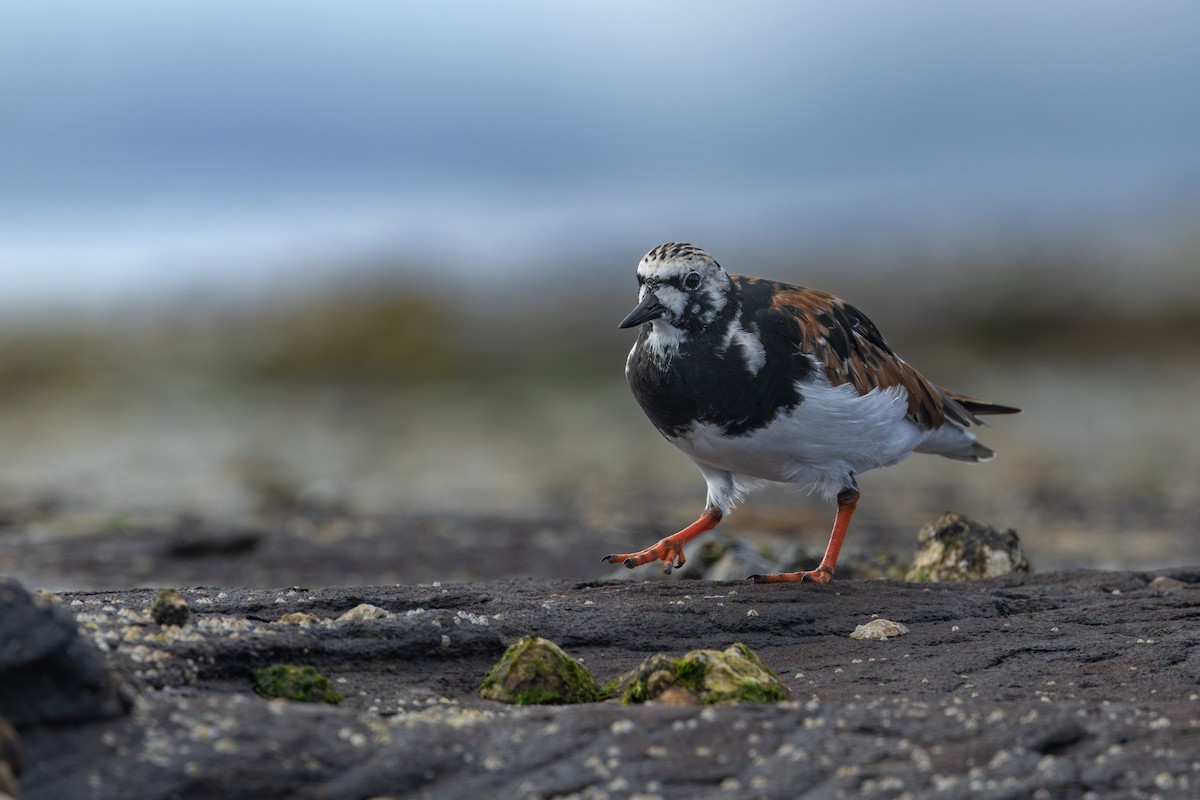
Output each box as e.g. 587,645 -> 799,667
618,242 -> 732,331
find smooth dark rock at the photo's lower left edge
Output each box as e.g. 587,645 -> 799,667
0,579 -> 128,728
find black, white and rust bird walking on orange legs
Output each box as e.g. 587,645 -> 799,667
604,242 -> 1020,584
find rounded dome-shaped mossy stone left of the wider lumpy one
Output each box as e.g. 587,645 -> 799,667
479,636 -> 605,705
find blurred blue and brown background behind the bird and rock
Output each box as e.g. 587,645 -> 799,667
0,0 -> 1200,588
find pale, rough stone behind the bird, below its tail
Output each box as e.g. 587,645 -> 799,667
905,511 -> 1033,582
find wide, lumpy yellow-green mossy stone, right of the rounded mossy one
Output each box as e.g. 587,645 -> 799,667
616,643 -> 788,704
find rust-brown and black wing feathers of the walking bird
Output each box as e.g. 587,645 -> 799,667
772,284 -> 980,429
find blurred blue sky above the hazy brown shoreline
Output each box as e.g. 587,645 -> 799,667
0,0 -> 1200,306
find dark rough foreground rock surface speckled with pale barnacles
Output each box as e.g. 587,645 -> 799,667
9,567 -> 1200,800
